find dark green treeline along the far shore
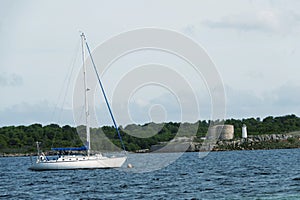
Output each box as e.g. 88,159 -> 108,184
0,115 -> 300,153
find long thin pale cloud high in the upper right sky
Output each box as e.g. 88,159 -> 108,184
202,10 -> 299,33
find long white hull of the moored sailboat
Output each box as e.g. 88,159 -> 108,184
29,156 -> 127,171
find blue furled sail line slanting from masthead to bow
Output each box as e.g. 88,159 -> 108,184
82,33 -> 126,151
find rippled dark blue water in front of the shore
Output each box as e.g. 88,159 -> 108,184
0,149 -> 300,199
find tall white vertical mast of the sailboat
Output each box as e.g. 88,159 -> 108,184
80,33 -> 91,156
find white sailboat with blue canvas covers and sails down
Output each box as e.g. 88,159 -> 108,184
29,33 -> 127,171
